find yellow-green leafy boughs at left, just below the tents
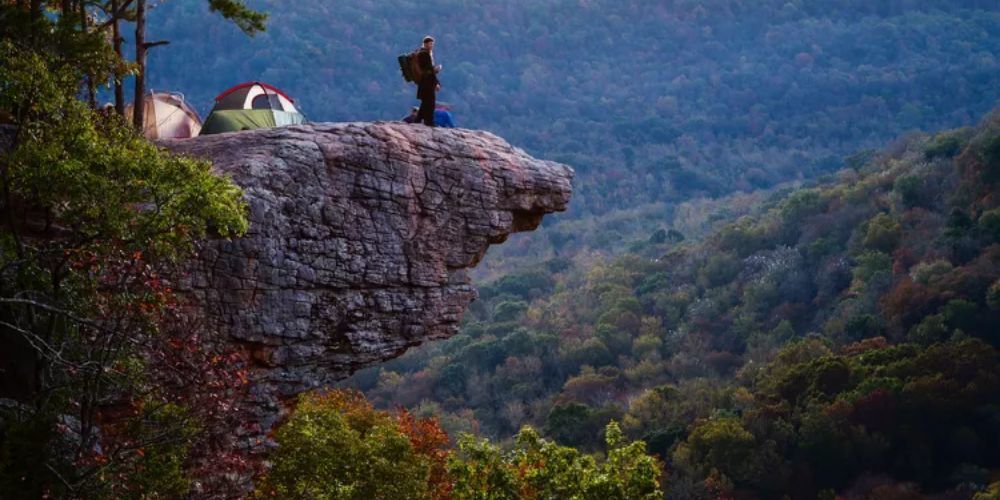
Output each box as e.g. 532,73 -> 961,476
0,41 -> 247,259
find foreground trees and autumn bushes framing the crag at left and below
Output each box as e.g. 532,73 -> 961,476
0,0 -> 663,499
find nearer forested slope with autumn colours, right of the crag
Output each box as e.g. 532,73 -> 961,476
349,107 -> 1000,498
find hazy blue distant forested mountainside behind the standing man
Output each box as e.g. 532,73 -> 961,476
141,0 -> 1000,215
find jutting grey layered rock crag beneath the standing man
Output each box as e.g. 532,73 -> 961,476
161,123 -> 573,432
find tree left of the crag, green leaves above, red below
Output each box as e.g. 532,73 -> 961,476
0,38 -> 247,496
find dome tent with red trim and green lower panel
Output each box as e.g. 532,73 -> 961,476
201,82 -> 306,134
